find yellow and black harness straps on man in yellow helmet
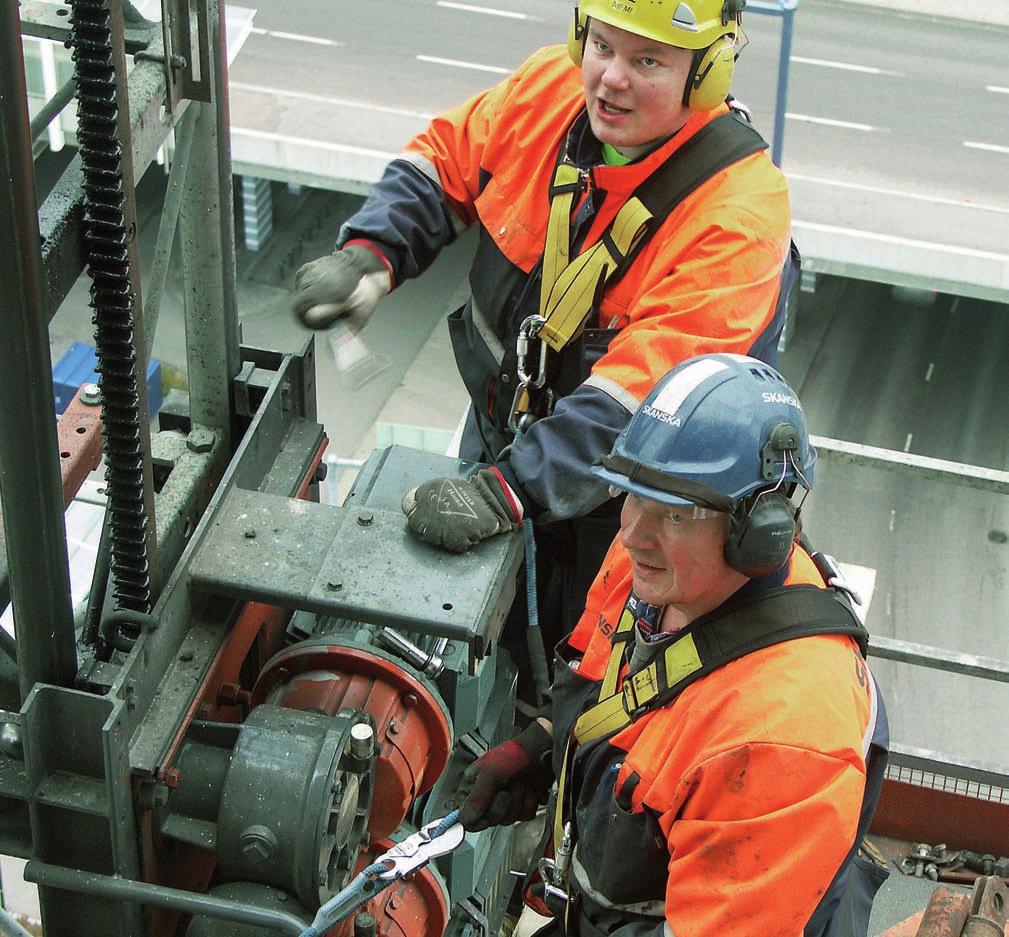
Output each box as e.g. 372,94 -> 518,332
539,111 -> 767,351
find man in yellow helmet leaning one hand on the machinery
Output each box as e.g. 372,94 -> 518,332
295,0 -> 795,673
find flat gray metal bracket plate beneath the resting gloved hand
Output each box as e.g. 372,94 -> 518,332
190,447 -> 522,669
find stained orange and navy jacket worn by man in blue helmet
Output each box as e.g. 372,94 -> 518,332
554,541 -> 888,937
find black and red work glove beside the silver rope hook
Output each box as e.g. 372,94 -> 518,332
457,722 -> 554,832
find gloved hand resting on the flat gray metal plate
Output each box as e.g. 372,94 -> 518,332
402,468 -> 522,553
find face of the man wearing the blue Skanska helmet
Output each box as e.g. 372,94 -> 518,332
621,494 -> 746,623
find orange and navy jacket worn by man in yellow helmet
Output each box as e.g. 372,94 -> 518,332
338,46 -> 790,519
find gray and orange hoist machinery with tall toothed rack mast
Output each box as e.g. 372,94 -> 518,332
0,0 -> 522,937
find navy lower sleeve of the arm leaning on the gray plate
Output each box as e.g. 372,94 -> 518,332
497,384 -> 631,521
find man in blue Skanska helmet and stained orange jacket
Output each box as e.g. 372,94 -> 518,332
460,354 -> 888,937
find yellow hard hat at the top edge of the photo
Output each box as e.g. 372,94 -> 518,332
576,0 -> 746,49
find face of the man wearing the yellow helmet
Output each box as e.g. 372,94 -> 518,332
581,19 -> 693,159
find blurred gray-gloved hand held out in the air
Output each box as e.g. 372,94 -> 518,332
294,244 -> 393,329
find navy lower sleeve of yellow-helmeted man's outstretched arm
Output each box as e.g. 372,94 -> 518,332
336,159 -> 459,283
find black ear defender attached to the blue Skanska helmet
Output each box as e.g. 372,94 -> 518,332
725,423 -> 799,579
